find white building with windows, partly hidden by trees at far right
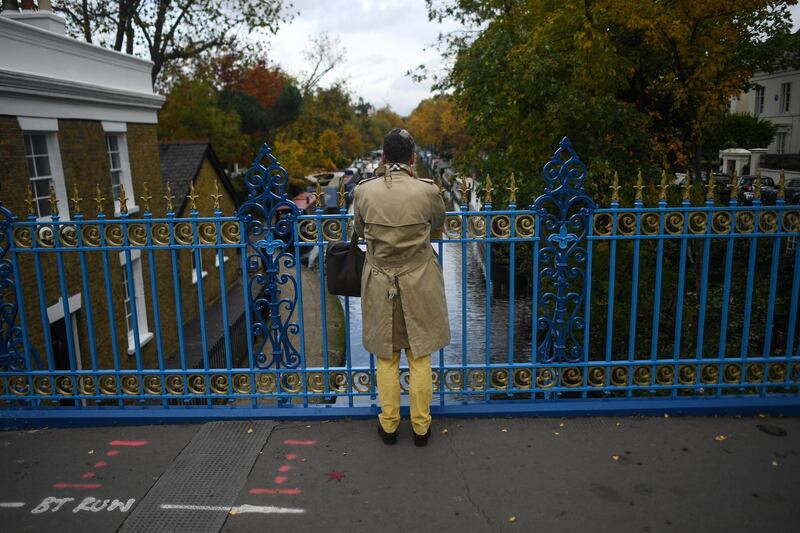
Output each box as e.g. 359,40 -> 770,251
731,70 -> 800,154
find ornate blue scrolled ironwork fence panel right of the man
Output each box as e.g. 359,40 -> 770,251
533,137 -> 595,362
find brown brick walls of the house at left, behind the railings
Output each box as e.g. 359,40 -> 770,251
0,116 -> 241,374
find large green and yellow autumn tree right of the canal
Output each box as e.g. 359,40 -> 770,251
428,0 -> 795,206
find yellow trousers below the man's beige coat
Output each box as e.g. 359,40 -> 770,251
376,350 -> 433,435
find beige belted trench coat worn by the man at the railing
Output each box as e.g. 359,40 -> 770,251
353,164 -> 450,358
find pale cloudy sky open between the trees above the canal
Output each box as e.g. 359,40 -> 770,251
269,0 -> 800,115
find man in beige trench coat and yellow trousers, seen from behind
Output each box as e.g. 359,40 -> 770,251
353,128 -> 450,446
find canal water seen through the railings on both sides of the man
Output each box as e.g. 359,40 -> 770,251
341,243 -> 532,367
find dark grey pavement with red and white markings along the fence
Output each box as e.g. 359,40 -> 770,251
0,416 -> 800,533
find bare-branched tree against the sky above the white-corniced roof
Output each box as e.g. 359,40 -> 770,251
53,0 -> 292,83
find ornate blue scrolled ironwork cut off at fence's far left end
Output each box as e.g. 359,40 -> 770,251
0,202 -> 25,370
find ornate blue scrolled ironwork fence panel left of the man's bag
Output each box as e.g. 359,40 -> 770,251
237,144 -> 301,368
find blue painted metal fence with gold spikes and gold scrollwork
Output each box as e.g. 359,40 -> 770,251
0,139 -> 800,424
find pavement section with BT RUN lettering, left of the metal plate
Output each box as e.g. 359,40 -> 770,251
0,425 -> 200,533
